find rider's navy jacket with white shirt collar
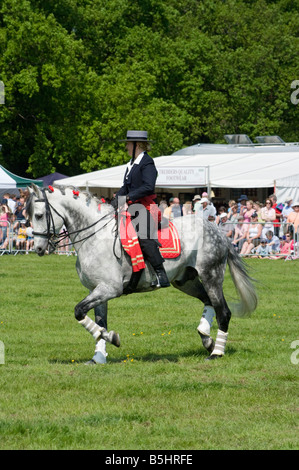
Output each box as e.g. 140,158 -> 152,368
116,152 -> 158,202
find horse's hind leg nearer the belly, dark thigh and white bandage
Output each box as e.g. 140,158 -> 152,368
173,277 -> 215,353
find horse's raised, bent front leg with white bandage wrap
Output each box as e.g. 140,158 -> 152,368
75,286 -> 120,347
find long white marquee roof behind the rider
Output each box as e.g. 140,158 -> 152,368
55,144 -> 299,189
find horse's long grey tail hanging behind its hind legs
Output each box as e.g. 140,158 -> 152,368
228,243 -> 258,317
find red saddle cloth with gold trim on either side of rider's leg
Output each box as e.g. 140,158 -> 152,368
119,212 -> 181,272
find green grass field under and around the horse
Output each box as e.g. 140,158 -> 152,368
0,254 -> 299,450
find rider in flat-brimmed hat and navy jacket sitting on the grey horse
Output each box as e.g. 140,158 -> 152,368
112,131 -> 170,291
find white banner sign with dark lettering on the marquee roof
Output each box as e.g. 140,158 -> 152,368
156,166 -> 207,187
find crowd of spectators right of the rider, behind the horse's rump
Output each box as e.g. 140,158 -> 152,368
160,192 -> 299,259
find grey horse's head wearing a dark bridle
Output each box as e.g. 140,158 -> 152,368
26,185 -> 64,256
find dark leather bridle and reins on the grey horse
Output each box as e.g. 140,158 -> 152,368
33,188 -> 117,251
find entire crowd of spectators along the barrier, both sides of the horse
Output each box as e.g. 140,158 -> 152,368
0,191 -> 299,259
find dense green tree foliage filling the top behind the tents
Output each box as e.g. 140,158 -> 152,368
0,0 -> 299,177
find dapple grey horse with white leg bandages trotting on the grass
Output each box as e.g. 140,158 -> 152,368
26,186 -> 257,363
